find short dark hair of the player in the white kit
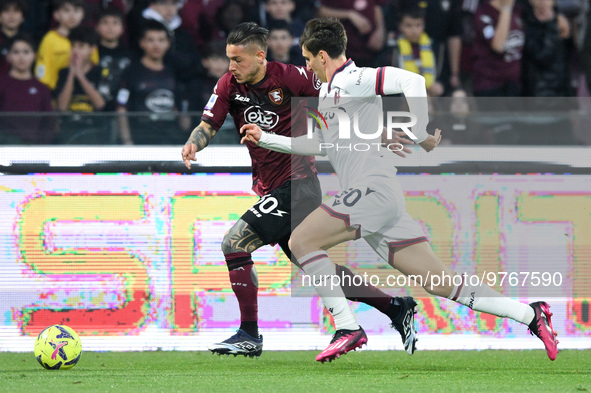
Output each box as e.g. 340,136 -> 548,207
300,18 -> 347,59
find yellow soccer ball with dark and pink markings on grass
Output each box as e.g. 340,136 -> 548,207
35,325 -> 82,370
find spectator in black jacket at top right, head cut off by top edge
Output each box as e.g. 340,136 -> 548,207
522,0 -> 573,97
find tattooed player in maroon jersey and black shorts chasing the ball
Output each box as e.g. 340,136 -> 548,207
181,22 -> 416,357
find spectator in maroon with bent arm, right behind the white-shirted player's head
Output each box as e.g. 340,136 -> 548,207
318,0 -> 386,67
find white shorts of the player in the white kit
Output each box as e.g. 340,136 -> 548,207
320,179 -> 428,266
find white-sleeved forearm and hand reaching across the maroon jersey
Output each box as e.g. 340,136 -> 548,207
240,124 -> 326,156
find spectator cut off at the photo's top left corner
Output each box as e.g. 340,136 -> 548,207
0,0 -> 27,75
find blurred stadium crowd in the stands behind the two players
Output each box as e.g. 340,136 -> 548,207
0,0 -> 591,145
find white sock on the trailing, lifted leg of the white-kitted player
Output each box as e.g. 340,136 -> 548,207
448,272 -> 535,325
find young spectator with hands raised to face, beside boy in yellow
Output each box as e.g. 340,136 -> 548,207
53,26 -> 105,144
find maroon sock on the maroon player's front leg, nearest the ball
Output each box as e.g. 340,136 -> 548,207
225,252 -> 259,337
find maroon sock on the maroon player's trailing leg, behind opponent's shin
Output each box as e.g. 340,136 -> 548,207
335,264 -> 392,314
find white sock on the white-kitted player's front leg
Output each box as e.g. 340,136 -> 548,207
298,251 -> 359,330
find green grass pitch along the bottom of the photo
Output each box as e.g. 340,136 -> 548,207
0,350 -> 591,393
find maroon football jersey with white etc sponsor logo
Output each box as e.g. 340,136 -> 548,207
201,61 -> 321,196
